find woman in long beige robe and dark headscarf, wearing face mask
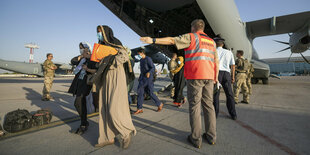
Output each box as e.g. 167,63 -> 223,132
95,25 -> 136,148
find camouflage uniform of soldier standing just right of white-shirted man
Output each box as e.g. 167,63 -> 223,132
234,57 -> 249,103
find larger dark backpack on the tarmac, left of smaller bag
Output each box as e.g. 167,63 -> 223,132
3,109 -> 33,132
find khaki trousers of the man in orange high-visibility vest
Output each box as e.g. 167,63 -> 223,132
187,80 -> 216,145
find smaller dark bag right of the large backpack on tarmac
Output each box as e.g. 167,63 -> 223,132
32,109 -> 52,126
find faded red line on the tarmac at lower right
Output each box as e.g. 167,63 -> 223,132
220,111 -> 297,155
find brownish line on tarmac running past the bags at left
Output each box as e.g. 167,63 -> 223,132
0,112 -> 99,140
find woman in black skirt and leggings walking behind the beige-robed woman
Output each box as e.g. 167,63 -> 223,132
68,42 -> 96,135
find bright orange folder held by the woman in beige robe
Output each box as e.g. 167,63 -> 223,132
90,43 -> 117,62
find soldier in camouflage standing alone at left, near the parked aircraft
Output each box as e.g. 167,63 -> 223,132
42,53 -> 57,101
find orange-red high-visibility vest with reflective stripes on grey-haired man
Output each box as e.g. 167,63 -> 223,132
184,32 -> 216,80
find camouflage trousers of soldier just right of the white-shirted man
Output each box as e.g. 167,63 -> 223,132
234,73 -> 249,103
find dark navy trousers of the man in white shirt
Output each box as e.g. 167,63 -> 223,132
213,71 -> 237,117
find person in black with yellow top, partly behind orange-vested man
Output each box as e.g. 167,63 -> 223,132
171,56 -> 185,107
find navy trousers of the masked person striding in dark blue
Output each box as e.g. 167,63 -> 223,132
137,75 -> 160,109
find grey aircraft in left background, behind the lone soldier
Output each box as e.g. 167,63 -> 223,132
0,59 -> 73,76
